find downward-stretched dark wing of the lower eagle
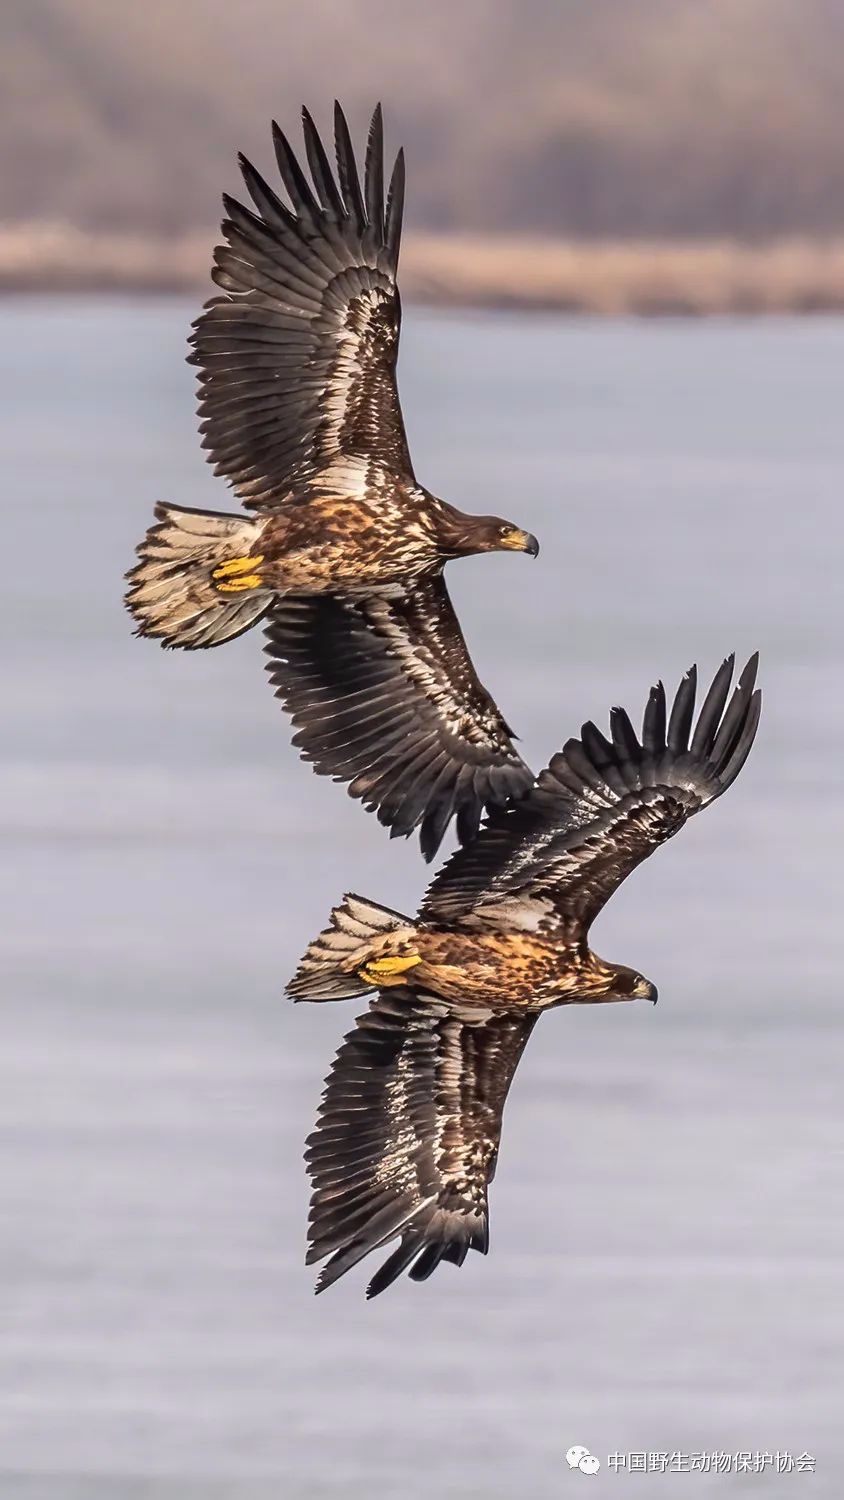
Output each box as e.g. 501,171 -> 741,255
306,989 -> 537,1298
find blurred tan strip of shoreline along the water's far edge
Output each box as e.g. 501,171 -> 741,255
0,224 -> 844,317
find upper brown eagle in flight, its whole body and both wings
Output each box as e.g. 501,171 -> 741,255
126,105 -> 538,860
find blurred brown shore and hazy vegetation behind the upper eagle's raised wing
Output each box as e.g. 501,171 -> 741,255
0,0 -> 844,314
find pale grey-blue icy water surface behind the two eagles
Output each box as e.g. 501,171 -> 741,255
0,302 -> 844,1500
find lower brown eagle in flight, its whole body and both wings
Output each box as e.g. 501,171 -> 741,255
288,657 -> 762,1296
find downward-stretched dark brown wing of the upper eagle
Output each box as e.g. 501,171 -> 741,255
267,576 -> 534,860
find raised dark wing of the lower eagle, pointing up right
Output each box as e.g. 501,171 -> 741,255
420,656 -> 762,941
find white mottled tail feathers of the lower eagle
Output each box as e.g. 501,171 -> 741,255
288,894 -> 414,1001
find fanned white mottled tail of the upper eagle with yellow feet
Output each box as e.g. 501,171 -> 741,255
126,504 -> 273,651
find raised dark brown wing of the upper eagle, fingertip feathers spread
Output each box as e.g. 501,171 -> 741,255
190,105 -> 412,509
